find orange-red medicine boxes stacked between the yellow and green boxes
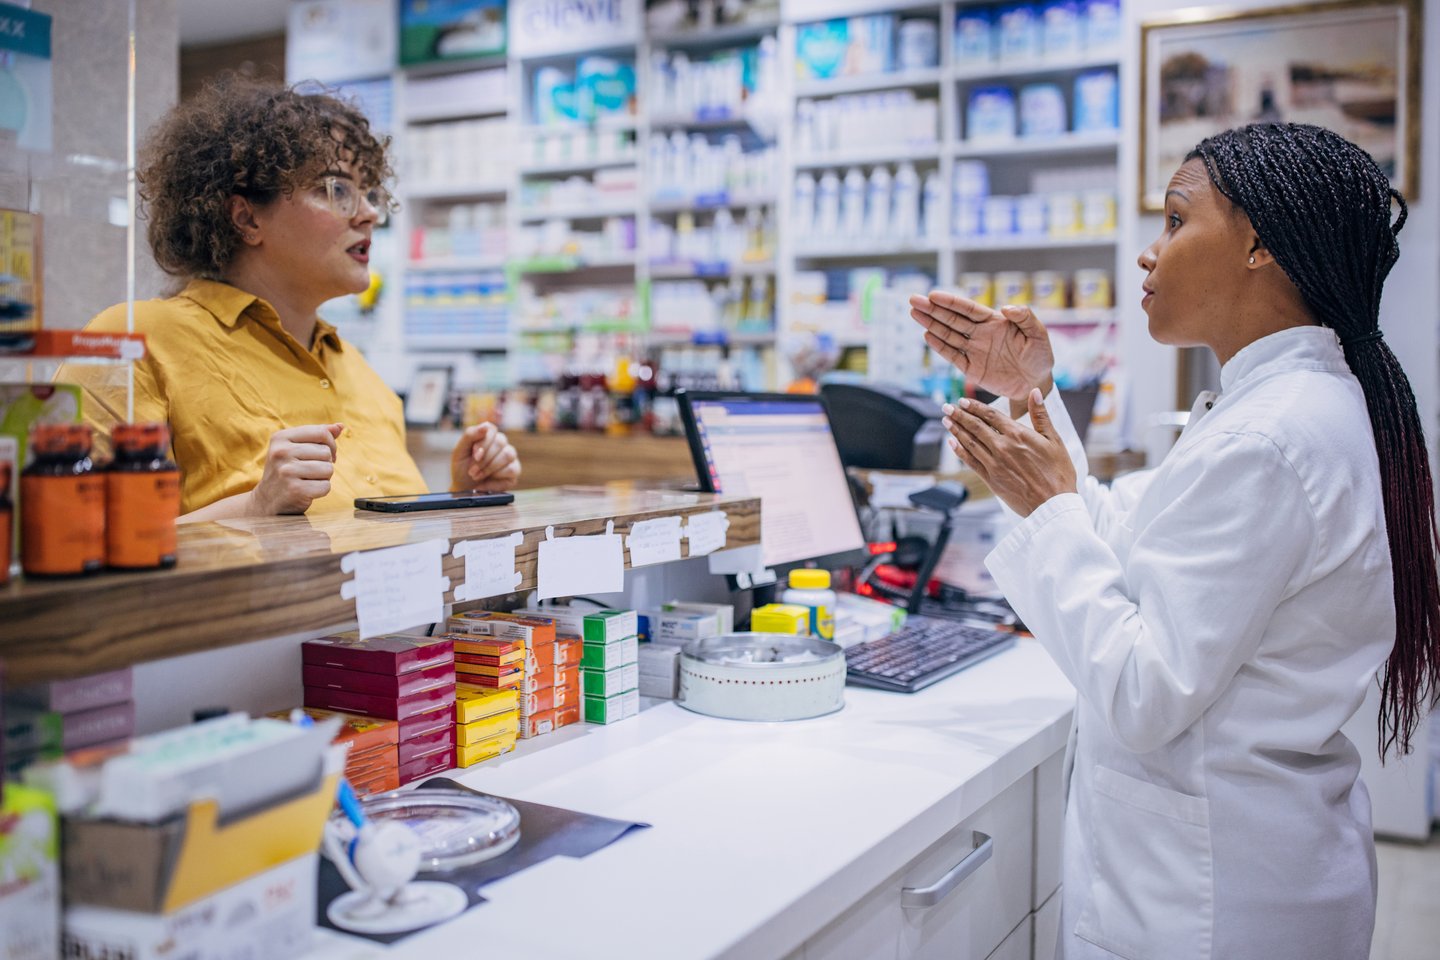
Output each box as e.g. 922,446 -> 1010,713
449,610 -> 580,738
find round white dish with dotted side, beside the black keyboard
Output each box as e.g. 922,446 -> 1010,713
675,633 -> 845,720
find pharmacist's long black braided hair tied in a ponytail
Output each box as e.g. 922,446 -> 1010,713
1188,124 -> 1440,757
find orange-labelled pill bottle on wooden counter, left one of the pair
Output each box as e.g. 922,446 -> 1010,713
20,423 -> 105,577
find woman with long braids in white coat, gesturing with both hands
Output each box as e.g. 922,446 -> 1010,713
912,124 -> 1440,960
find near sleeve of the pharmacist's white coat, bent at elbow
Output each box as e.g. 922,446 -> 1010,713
986,433 -> 1318,753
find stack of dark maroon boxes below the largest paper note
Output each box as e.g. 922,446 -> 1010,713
301,633 -> 455,784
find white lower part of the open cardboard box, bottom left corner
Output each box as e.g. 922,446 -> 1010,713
58,853 -> 318,960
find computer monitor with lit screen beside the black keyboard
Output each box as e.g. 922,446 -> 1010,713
683,393 -> 865,567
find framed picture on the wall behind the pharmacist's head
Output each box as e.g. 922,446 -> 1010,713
1139,0 -> 1423,213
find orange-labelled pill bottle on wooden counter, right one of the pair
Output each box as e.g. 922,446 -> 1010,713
105,423 -> 180,570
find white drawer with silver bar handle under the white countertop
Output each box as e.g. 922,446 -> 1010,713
805,774 -> 1035,960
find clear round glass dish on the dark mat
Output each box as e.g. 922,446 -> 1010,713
349,790 -> 520,874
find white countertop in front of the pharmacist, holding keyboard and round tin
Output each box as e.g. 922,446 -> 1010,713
311,639 -> 1074,960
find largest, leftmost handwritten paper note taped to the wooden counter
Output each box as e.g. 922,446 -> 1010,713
340,540 -> 449,638
